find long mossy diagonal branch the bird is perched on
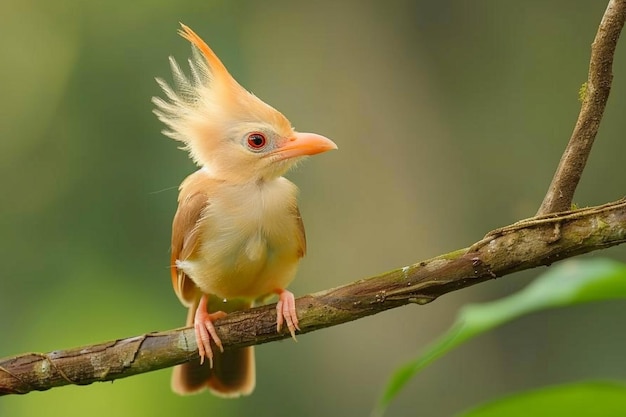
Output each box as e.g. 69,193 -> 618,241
0,200 -> 626,395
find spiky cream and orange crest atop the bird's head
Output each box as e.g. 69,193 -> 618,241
152,23 -> 291,166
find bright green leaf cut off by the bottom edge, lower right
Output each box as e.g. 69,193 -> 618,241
461,381 -> 626,417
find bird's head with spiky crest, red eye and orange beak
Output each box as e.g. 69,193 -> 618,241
153,24 -> 337,182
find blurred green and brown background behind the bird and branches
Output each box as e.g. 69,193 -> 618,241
0,0 -> 626,417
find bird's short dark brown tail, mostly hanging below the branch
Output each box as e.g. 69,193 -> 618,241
172,297 -> 256,398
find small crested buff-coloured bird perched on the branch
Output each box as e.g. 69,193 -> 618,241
153,24 -> 337,397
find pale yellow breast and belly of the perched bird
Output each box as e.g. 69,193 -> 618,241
178,177 -> 303,299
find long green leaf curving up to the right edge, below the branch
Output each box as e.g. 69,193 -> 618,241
373,259 -> 626,416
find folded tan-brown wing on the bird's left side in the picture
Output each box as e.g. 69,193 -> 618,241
170,171 -> 209,305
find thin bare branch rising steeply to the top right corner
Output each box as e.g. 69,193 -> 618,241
537,0 -> 626,216
